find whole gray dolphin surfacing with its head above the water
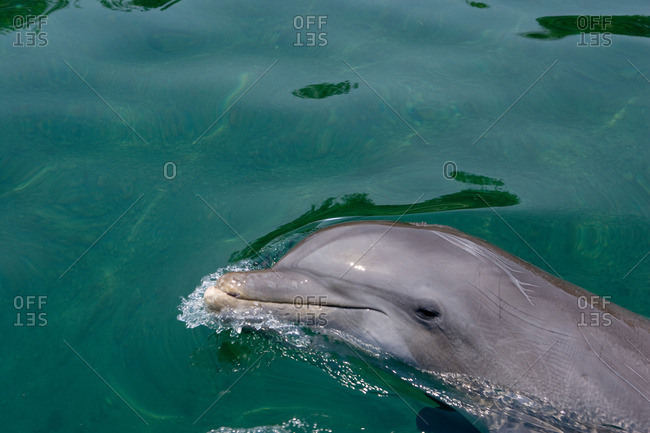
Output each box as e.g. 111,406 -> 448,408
204,221 -> 650,432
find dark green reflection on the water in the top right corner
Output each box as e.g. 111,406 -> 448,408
521,15 -> 650,40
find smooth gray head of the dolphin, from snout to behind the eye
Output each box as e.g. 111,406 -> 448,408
204,222 -> 544,372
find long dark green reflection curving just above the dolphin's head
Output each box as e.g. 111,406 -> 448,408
230,172 -> 519,263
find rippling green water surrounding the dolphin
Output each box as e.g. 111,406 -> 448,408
0,0 -> 650,432
